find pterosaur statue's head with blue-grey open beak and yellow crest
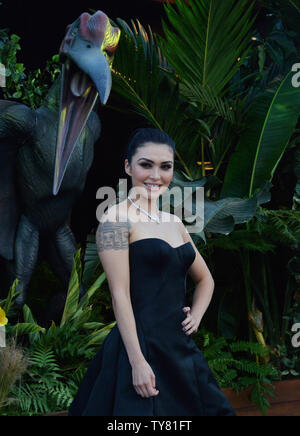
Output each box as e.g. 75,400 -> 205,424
53,11 -> 121,195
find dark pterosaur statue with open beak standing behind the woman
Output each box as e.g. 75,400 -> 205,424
0,11 -> 120,308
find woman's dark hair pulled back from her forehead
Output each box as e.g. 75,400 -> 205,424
126,128 -> 176,165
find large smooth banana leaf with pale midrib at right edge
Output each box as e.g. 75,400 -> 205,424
221,72 -> 300,198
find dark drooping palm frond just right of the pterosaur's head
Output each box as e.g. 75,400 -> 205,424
113,19 -> 202,179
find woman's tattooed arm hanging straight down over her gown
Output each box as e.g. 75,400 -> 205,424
96,208 -> 158,397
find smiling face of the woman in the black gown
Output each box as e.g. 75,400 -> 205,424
125,142 -> 174,199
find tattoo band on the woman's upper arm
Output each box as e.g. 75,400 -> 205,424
96,221 -> 130,253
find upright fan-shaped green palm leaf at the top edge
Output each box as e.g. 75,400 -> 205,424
159,0 -> 255,96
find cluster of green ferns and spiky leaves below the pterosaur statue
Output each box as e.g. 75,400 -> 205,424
1,250 -> 115,414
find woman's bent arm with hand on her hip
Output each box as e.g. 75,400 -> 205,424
178,218 -> 215,335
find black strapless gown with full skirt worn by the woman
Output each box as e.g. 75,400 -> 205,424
69,238 -> 236,416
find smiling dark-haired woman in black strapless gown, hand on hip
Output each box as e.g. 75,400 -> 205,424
69,129 -> 235,416
